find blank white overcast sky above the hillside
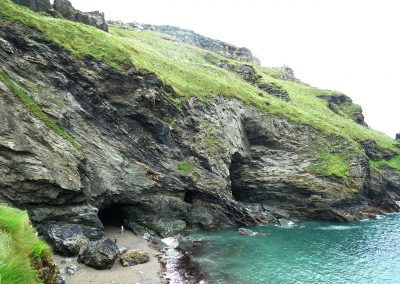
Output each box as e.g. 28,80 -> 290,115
71,0 -> 400,137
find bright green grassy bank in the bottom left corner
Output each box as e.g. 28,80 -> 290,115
0,206 -> 52,284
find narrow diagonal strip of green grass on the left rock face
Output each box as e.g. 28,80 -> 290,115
0,70 -> 81,150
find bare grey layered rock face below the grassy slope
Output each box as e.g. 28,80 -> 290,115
0,19 -> 400,255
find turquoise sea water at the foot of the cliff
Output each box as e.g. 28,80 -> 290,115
187,214 -> 400,284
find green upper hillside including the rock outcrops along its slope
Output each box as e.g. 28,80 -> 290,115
0,0 -> 400,171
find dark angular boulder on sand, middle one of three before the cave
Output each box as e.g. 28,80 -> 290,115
78,238 -> 119,270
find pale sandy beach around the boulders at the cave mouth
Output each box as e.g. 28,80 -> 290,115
54,226 -> 164,284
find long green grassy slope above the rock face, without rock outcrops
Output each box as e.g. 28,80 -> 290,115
0,0 -> 398,175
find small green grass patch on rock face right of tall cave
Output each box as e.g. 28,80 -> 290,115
309,152 -> 350,178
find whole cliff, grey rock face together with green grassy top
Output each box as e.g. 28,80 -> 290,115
0,0 -> 400,255
